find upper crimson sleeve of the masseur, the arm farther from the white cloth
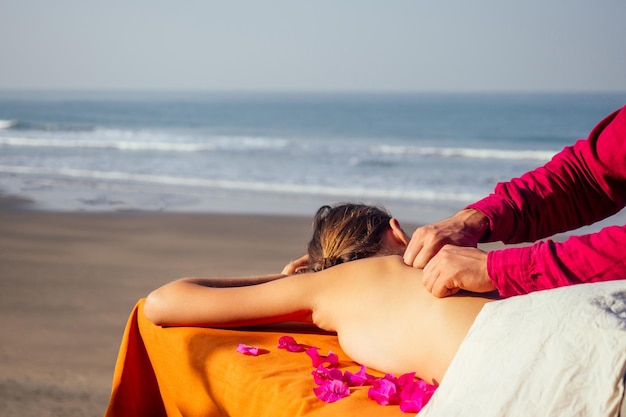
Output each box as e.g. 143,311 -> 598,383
469,107 -> 626,243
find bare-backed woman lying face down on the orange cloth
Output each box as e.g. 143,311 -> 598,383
144,205 -> 492,382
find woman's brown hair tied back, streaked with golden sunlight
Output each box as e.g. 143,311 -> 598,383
303,203 -> 391,272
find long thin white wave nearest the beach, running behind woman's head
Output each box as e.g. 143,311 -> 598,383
0,165 -> 480,202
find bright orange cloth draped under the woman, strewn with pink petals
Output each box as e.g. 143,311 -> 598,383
105,300 -> 406,417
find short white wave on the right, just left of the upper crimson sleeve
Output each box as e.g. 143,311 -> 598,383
372,145 -> 557,162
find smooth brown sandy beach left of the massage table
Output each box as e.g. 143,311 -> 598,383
0,198 -> 358,417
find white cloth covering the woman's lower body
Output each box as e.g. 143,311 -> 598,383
419,281 -> 626,417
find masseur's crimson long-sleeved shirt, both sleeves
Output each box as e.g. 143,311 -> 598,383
468,107 -> 626,297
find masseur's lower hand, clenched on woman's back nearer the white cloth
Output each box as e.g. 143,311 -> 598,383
422,245 -> 496,297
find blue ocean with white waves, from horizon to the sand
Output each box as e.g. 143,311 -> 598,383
0,92 -> 626,228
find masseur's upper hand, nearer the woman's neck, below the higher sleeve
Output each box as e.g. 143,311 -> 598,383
404,209 -> 489,268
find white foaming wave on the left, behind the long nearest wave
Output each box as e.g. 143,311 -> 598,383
0,133 -> 286,152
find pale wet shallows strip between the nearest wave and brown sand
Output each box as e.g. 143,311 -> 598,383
0,180 -> 458,224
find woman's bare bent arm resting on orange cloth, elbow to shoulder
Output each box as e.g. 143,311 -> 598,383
144,275 -> 312,327
